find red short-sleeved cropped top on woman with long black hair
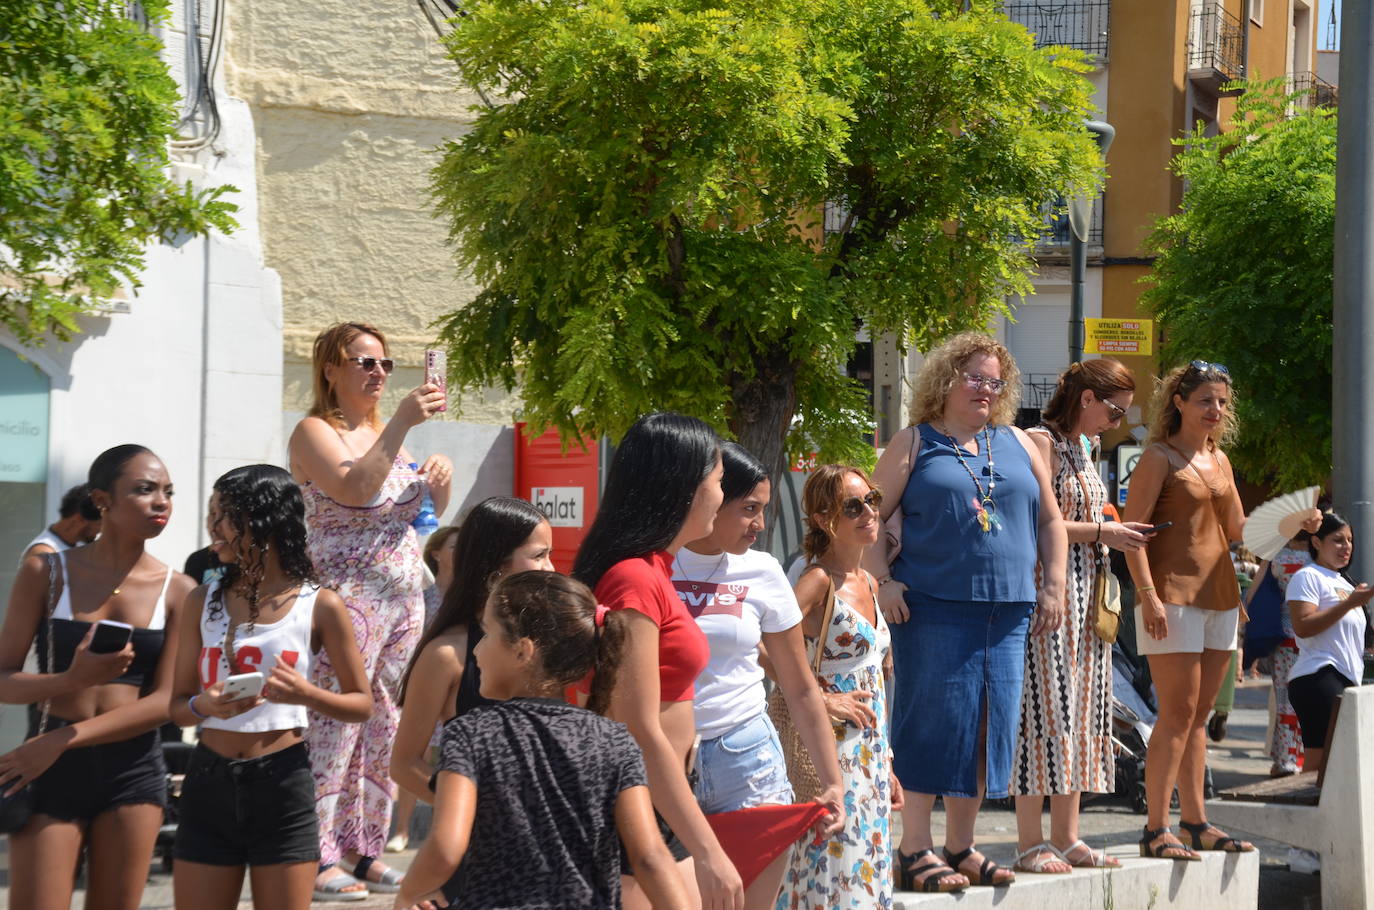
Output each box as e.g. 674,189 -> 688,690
594,551 -> 710,701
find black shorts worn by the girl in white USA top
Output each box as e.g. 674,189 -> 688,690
172,742 -> 320,866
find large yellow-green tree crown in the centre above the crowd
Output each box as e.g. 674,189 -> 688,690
434,0 -> 1099,469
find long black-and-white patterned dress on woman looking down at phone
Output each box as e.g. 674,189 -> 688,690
1011,426 -> 1114,796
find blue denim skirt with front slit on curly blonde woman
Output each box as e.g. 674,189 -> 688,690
890,592 -> 1035,799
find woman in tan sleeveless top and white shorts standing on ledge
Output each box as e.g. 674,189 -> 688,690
1125,360 -> 1319,859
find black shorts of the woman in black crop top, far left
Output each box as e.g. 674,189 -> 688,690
30,718 -> 168,822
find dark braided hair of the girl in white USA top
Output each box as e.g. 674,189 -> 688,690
206,465 -> 317,651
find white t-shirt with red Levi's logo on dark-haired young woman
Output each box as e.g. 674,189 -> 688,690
673,547 -> 801,740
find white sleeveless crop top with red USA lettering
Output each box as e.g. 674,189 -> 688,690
196,579 -> 320,733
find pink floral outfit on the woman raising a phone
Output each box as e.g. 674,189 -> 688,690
301,458 -> 425,866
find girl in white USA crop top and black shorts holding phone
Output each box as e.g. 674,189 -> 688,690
172,465 -> 372,910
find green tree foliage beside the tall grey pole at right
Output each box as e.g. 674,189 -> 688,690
1143,82 -> 1336,491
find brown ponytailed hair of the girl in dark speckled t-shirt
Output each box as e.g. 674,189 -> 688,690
482,572 -> 628,713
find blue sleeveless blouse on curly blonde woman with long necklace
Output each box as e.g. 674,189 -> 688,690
892,423 -> 1040,603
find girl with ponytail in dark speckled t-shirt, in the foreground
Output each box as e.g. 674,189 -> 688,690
396,570 -> 688,910
